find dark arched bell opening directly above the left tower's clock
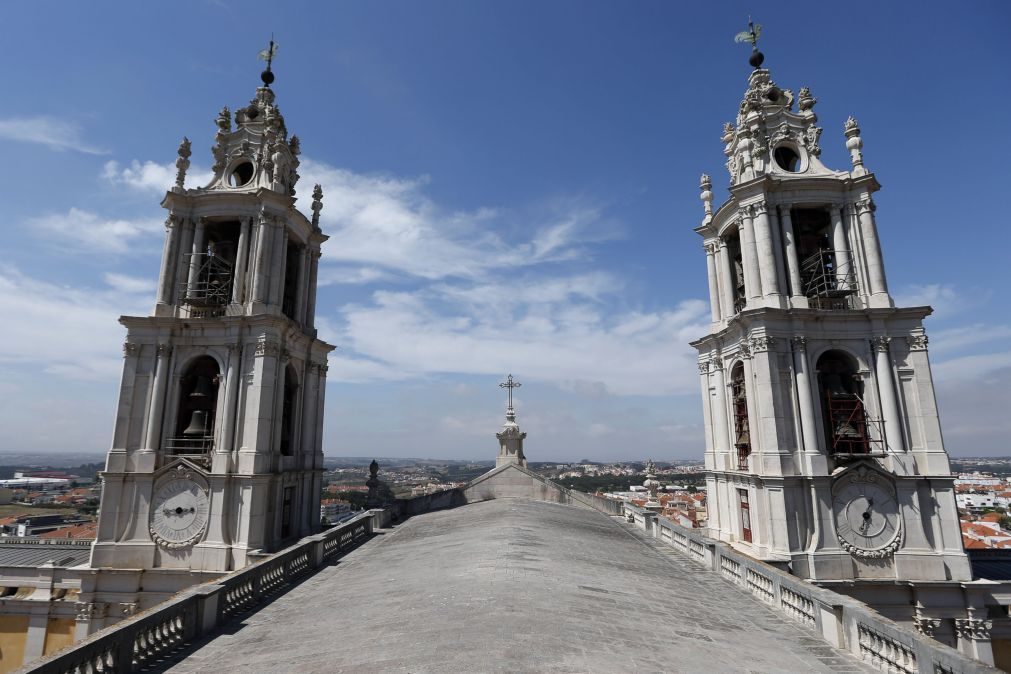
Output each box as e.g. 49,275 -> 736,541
168,356 -> 220,454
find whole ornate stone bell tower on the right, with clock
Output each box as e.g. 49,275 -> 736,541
693,30 -> 971,581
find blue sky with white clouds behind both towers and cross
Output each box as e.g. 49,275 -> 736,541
0,0 -> 1011,461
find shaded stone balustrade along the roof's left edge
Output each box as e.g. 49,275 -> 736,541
18,510 -> 384,674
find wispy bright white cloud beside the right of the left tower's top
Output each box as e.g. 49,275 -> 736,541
299,159 -> 616,280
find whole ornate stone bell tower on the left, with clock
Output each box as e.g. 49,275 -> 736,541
91,50 -> 333,587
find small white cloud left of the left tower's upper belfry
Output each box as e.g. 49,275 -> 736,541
31,208 -> 164,253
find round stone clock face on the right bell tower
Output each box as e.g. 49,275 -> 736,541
832,480 -> 900,557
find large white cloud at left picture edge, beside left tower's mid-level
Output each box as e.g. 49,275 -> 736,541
0,267 -> 150,380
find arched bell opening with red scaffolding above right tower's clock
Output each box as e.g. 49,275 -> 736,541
817,351 -> 870,454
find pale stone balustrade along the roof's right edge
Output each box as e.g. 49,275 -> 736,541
624,503 -> 999,674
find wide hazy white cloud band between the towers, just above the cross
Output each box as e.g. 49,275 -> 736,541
327,279 -> 707,395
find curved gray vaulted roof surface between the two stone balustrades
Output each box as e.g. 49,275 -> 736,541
159,498 -> 870,674
